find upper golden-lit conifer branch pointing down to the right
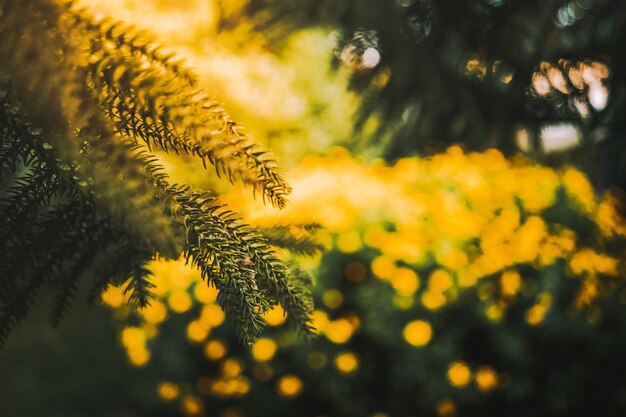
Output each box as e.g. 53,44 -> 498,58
77,17 -> 291,207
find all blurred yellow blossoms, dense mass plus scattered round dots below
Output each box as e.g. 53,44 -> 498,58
102,147 -> 624,416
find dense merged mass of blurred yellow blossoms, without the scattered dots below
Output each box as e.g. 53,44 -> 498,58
223,146 -> 623,316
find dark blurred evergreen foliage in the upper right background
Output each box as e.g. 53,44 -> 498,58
233,0 -> 626,188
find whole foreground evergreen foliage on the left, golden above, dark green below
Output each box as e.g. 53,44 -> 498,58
0,0 -> 317,344
